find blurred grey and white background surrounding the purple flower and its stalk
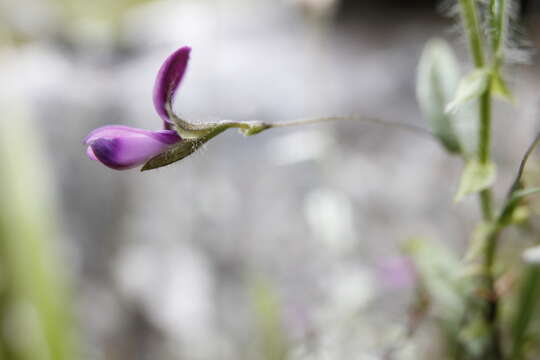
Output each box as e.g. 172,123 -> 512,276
0,0 -> 540,360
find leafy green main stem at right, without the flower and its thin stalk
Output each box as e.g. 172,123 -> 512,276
413,0 -> 539,360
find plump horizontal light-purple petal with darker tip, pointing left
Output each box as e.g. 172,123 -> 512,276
84,125 -> 181,170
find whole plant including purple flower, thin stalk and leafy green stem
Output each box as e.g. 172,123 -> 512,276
86,0 -> 540,360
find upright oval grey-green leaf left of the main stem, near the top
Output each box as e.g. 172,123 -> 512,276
416,39 -> 460,153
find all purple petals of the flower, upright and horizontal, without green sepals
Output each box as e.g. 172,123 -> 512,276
84,46 -> 191,170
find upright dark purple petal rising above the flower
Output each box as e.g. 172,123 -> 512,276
154,46 -> 191,129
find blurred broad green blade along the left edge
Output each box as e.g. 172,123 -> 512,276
0,49 -> 81,360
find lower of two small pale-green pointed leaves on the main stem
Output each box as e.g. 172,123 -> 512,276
454,159 -> 497,202
